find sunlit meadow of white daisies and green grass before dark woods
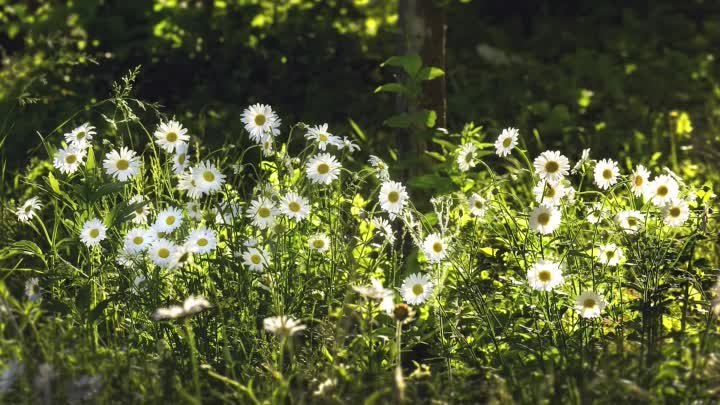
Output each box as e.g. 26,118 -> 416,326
0,1 -> 720,405
